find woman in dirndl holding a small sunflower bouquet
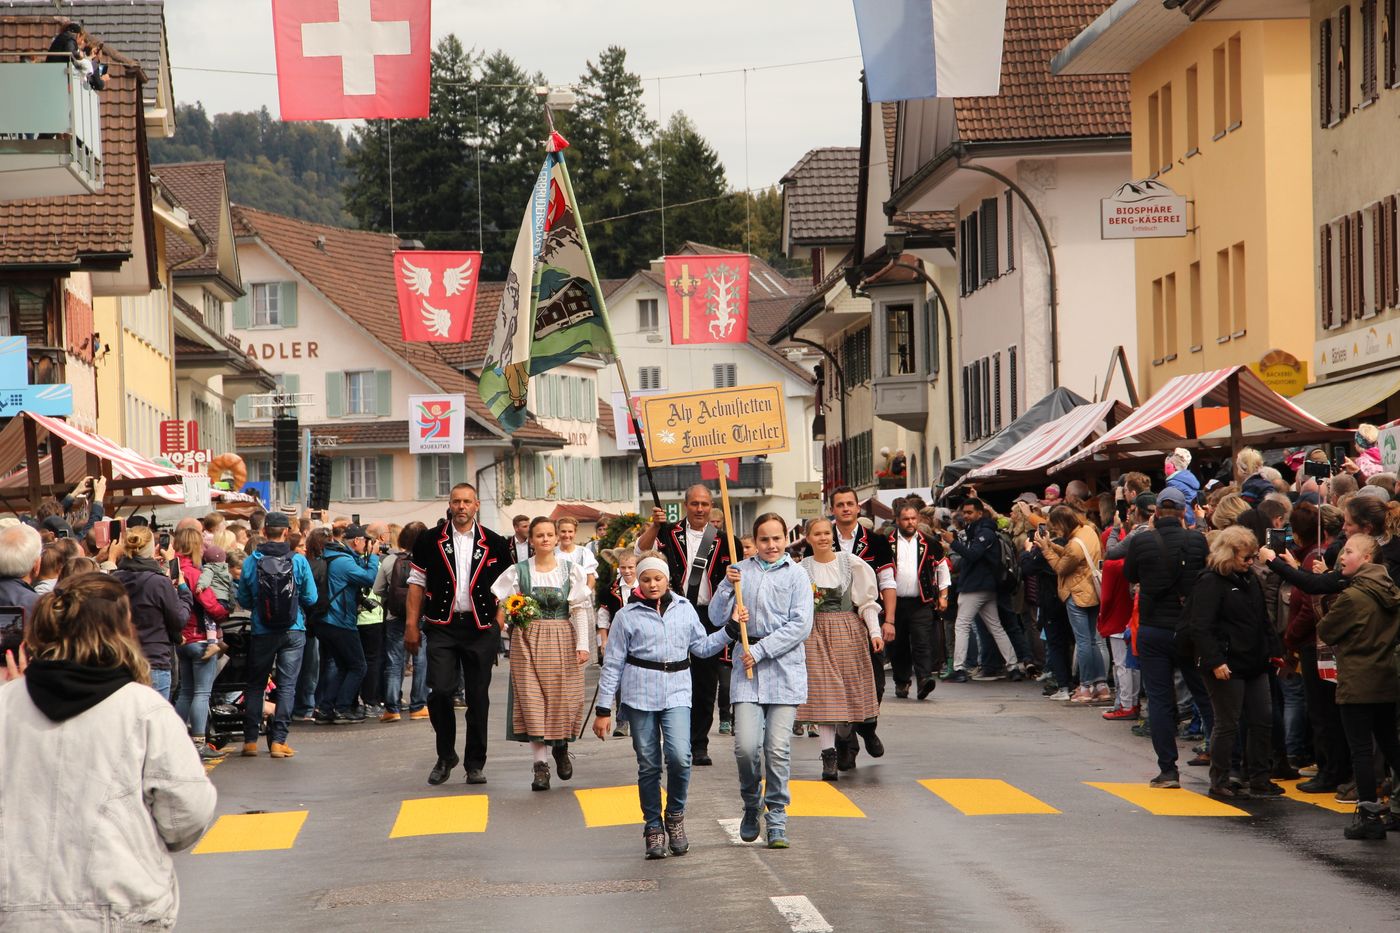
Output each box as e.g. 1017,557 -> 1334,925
491,518 -> 592,790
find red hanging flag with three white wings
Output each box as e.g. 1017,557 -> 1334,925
393,249 -> 482,343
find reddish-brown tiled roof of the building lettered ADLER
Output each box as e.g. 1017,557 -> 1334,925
234,205 -> 563,444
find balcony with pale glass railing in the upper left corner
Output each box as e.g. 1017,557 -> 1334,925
0,62 -> 102,200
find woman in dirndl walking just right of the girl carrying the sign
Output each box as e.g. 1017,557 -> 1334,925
797,518 -> 885,780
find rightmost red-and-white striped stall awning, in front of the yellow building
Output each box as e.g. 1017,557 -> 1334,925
1050,366 -> 1333,472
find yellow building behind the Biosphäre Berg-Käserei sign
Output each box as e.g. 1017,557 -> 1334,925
1053,0 -> 1315,394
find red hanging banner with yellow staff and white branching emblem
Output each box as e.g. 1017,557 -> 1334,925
666,254 -> 749,345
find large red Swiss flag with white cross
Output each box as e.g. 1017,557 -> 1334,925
272,0 -> 433,120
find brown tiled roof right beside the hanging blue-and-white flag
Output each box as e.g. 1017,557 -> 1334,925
955,0 -> 1131,143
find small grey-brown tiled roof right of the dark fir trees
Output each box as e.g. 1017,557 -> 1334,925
780,146 -> 861,244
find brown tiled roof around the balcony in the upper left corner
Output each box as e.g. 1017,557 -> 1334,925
0,17 -> 150,268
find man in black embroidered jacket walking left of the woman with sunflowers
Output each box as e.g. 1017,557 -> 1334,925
403,483 -> 514,785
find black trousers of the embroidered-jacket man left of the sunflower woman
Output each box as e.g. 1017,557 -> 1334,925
423,622 -> 501,769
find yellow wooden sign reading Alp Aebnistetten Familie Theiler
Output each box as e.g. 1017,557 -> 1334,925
640,382 -> 790,462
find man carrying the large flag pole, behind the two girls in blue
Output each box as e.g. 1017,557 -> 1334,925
637,483 -> 729,765
